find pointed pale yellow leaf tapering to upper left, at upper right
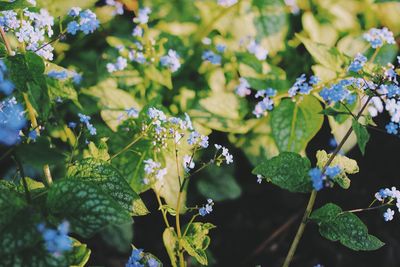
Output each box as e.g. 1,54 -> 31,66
296,34 -> 344,72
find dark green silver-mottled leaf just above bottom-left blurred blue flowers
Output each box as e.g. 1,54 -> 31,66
47,179 -> 132,238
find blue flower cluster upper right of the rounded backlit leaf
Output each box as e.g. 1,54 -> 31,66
319,79 -> 356,104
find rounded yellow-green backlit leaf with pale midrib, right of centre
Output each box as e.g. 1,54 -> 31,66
271,96 -> 324,152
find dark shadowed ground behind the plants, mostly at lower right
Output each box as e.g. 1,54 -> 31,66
88,117 -> 400,267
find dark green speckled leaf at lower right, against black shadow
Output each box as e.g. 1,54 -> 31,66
310,203 -> 384,251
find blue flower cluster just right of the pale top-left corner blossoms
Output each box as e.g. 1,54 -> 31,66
67,7 -> 100,35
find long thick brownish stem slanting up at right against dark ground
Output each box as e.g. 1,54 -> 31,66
282,96 -> 372,267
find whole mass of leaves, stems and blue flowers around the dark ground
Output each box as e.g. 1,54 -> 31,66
0,0 -> 400,267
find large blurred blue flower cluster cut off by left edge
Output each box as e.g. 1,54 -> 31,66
0,97 -> 26,146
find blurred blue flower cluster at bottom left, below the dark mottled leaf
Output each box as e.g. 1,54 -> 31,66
37,221 -> 72,257
